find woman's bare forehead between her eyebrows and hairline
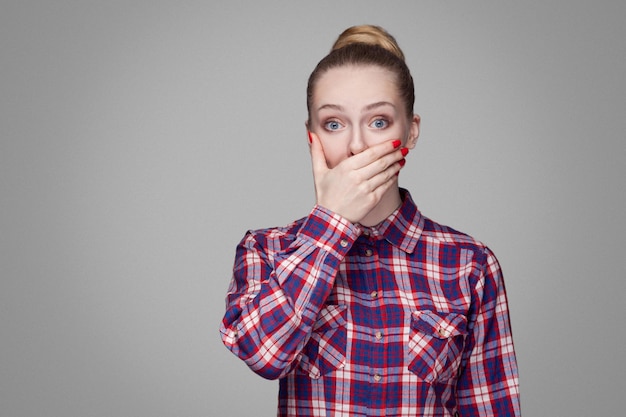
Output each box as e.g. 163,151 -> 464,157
313,65 -> 400,107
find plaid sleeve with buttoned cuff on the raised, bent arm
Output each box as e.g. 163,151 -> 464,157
220,206 -> 360,379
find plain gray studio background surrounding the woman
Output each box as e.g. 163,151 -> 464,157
0,0 -> 626,417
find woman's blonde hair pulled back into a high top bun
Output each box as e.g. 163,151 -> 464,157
306,25 -> 415,118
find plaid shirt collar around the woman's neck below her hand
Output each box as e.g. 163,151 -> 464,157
361,188 -> 424,253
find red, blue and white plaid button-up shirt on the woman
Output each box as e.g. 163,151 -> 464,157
220,190 -> 520,417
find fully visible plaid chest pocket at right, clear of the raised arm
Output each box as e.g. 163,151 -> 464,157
408,310 -> 467,384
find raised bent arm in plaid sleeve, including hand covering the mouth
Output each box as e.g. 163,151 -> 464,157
220,133 -> 404,379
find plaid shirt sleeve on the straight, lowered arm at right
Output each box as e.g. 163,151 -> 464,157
457,249 -> 521,417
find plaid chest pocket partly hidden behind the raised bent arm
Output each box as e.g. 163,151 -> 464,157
299,305 -> 347,379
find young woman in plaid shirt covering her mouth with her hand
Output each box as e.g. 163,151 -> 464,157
220,26 -> 520,417
